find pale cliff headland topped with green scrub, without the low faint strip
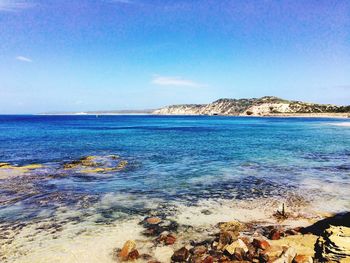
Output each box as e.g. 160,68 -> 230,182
153,96 -> 350,117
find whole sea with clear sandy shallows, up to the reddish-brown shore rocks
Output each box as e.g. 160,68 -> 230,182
0,115 -> 350,262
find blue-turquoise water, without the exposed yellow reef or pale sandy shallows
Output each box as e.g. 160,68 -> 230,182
0,116 -> 350,222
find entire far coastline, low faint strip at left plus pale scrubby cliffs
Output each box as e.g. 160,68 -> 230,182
38,96 -> 350,118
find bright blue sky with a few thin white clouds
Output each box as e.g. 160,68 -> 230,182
0,0 -> 350,114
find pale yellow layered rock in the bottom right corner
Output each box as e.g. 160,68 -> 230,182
315,225 -> 350,262
